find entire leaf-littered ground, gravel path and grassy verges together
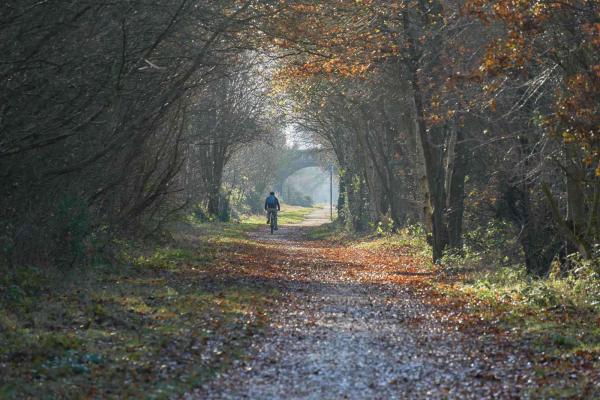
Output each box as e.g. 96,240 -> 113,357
0,208 -> 600,399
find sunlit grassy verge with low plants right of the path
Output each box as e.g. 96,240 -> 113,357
433,267 -> 600,399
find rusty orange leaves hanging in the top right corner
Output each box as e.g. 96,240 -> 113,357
465,0 -> 600,175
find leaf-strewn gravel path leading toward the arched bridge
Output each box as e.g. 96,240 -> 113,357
185,210 -> 530,399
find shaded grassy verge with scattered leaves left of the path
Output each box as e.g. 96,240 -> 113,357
0,220 -> 277,399
